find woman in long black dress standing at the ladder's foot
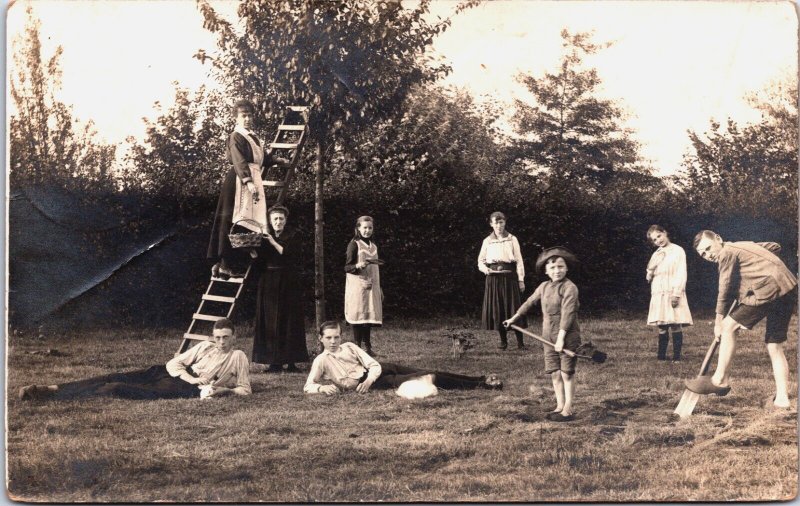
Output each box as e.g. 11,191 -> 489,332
252,205 -> 308,372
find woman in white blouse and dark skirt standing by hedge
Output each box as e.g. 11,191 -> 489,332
478,211 -> 527,350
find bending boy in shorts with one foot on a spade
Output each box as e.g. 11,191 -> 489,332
686,230 -> 797,408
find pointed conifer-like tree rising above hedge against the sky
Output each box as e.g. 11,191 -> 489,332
513,29 -> 643,187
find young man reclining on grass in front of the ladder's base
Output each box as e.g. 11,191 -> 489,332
19,318 -> 252,400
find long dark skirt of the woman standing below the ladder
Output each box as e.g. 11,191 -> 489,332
252,267 -> 308,364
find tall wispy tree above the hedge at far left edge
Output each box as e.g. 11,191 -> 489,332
9,6 -> 116,186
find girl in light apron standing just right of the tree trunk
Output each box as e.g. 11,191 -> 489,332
344,216 -> 383,356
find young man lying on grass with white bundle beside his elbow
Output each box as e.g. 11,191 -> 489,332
303,321 -> 503,395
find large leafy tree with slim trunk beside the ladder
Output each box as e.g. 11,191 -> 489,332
197,0 -> 479,321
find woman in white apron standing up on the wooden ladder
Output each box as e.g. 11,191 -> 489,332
206,100 -> 289,277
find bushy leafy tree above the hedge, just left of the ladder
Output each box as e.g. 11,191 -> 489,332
124,83 -> 232,214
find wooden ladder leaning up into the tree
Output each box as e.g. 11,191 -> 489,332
178,105 -> 309,353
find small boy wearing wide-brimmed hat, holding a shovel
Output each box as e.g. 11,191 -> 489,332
503,246 -> 581,422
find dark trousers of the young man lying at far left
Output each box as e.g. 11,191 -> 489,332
50,365 -> 200,400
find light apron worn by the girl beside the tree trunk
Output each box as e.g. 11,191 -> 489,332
344,240 -> 383,325
